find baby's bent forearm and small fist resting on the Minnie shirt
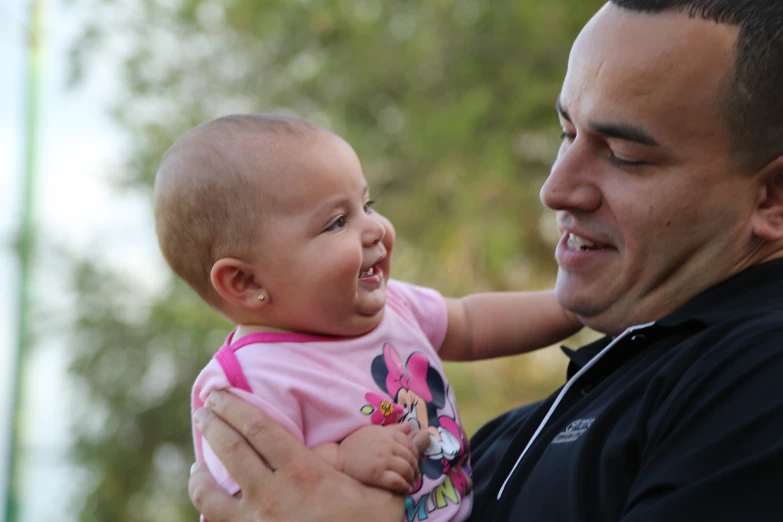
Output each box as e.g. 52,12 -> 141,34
313,422 -> 422,495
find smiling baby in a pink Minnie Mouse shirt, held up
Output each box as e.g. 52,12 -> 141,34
155,114 -> 581,520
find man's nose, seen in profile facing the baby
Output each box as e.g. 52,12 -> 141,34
539,141 -> 602,212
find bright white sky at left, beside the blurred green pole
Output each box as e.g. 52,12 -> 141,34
0,0 -> 163,522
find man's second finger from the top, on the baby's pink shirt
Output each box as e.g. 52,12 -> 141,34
195,408 -> 272,486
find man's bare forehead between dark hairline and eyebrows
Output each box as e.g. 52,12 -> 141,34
560,4 -> 737,140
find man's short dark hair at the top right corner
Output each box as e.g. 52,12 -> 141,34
611,0 -> 783,167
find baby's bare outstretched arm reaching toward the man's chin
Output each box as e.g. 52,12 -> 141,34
439,290 -> 582,361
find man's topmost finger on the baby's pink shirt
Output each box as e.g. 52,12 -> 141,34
207,392 -> 316,470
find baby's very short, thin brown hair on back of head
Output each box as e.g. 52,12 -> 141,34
154,114 -> 323,302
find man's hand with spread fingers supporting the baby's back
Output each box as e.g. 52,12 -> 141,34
188,392 -> 429,522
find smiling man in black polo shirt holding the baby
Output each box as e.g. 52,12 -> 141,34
190,0 -> 783,522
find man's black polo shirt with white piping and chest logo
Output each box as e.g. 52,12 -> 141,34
471,260 -> 783,522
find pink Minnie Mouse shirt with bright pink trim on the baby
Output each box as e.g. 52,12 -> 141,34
192,280 -> 472,522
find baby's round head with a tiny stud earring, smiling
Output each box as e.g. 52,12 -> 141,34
154,114 -> 394,336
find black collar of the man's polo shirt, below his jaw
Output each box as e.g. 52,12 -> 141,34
561,259 -> 783,370
